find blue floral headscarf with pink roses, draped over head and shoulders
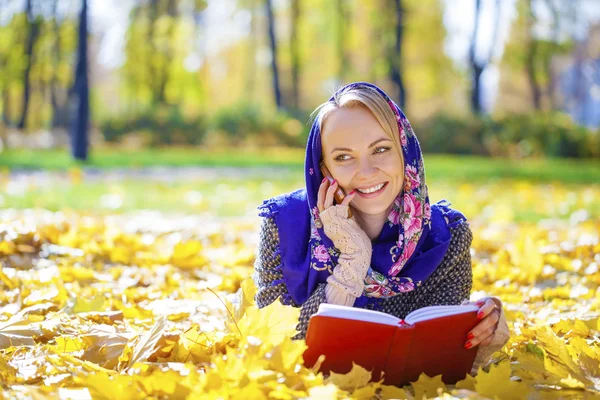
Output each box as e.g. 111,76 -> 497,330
258,82 -> 465,307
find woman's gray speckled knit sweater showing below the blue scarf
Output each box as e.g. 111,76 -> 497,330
254,217 -> 473,339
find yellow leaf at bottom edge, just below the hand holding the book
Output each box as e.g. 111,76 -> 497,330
475,361 -> 530,400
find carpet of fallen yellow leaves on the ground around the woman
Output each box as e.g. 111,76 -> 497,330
0,182 -> 600,399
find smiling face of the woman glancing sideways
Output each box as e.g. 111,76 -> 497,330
321,106 -> 404,214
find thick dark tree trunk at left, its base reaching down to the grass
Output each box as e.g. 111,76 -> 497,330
71,0 -> 90,161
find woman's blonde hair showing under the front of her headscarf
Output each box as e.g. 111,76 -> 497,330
311,86 -> 404,159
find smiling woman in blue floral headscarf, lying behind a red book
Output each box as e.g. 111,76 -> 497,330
254,82 -> 508,373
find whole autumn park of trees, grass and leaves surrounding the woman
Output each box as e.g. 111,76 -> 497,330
0,0 -> 600,398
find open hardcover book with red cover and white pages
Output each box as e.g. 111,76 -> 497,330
304,304 -> 479,385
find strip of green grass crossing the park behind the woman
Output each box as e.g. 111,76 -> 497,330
0,148 -> 600,183
